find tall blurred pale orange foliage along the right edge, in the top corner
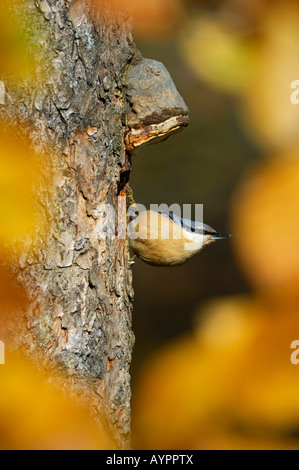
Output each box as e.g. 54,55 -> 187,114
242,2 -> 299,148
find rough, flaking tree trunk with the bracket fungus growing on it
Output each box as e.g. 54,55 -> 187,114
0,0 -> 188,449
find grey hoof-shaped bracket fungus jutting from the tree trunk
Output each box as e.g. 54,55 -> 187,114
125,59 -> 189,149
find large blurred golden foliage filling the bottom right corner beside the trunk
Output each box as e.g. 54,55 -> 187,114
135,297 -> 299,449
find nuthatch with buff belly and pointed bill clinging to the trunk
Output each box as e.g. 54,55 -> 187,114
127,206 -> 231,266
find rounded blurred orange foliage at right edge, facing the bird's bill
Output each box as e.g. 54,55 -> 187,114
231,147 -> 299,302
